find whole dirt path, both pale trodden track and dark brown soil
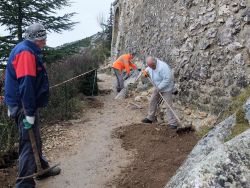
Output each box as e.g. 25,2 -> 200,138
0,74 -> 197,188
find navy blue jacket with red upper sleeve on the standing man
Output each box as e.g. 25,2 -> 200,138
5,40 -> 49,116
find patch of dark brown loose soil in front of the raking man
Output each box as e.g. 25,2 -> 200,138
112,124 -> 198,188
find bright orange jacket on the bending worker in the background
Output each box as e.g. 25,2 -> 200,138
112,54 -> 137,74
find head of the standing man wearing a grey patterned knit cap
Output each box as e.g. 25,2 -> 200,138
25,23 -> 47,48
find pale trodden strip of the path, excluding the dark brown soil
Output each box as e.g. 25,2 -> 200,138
38,75 -> 143,188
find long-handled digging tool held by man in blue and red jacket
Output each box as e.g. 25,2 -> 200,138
17,128 -> 60,180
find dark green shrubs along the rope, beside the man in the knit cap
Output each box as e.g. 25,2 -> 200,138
40,53 -> 98,122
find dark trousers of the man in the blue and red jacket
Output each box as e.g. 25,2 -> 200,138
15,110 -> 49,188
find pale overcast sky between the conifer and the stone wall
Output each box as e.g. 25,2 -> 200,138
0,0 -> 114,47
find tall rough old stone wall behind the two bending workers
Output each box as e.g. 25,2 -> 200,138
112,0 -> 250,113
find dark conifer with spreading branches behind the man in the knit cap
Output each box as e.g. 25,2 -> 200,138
0,0 -> 77,59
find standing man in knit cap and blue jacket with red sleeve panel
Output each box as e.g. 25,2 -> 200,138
5,23 -> 61,188
